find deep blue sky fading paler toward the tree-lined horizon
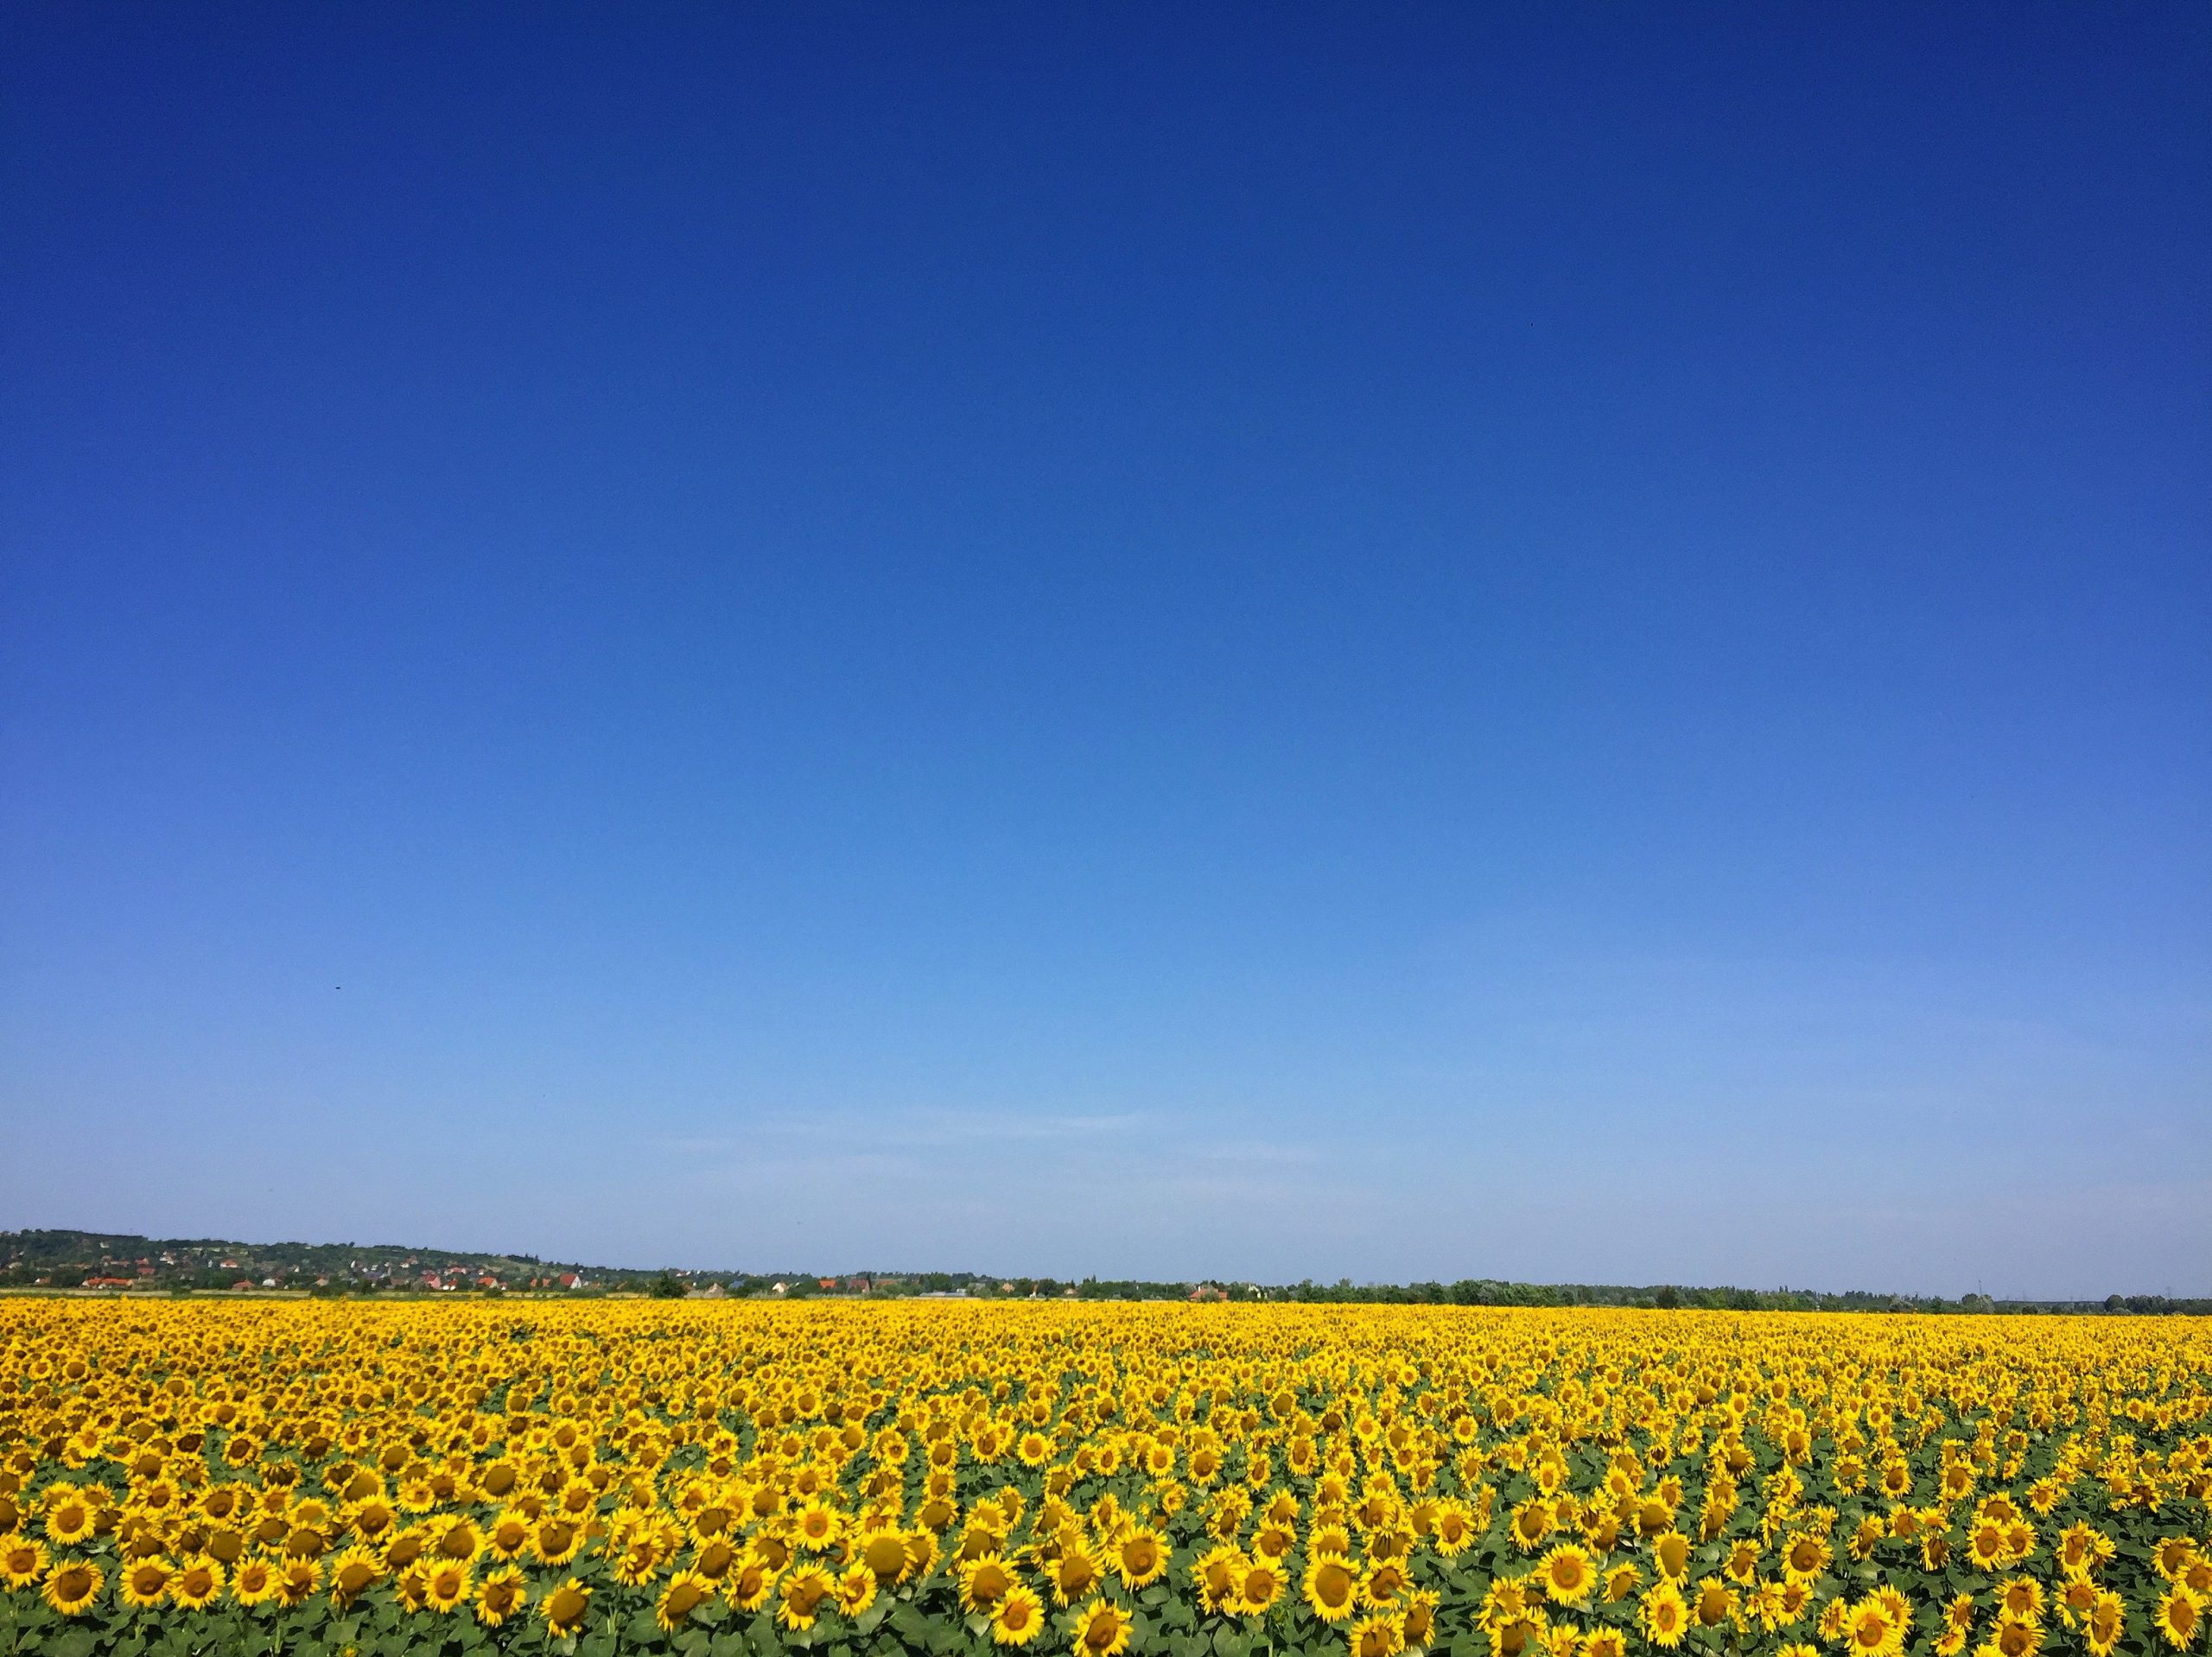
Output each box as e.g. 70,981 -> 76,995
0,3 -> 2212,1297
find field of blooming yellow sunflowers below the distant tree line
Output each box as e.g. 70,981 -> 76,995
0,1298 -> 2212,1657
